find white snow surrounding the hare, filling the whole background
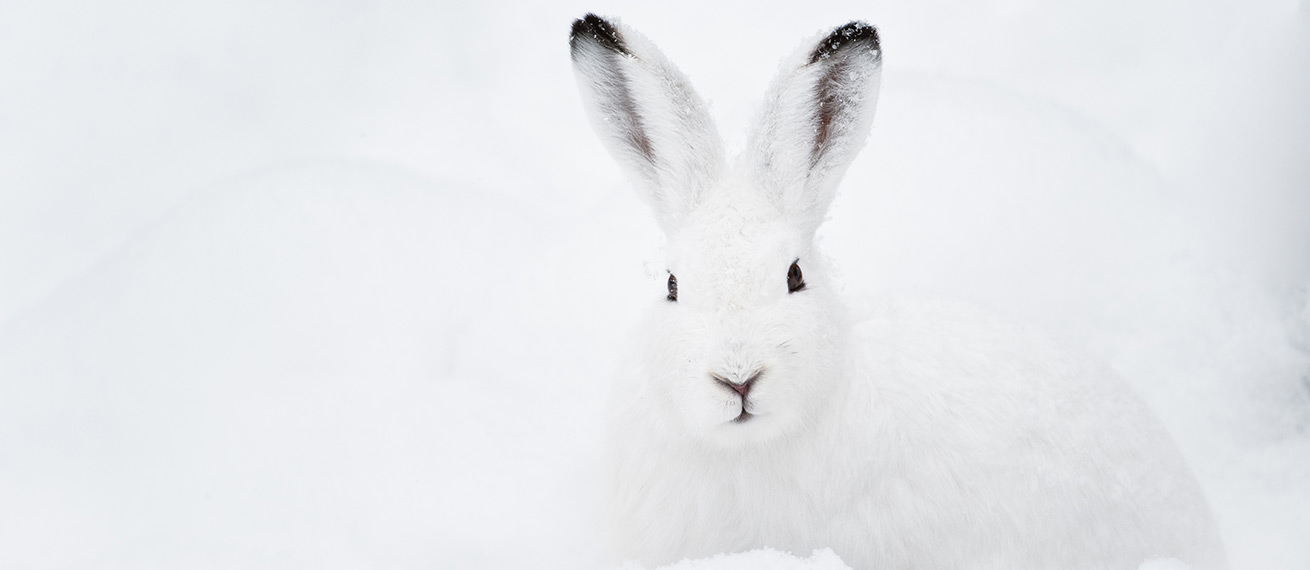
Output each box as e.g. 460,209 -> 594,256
0,0 -> 1310,570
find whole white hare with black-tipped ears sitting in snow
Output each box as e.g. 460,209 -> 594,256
570,14 -> 1225,570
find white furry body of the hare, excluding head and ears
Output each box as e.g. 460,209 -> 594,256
609,298 -> 1224,570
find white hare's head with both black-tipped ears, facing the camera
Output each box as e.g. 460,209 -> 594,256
570,14 -> 882,446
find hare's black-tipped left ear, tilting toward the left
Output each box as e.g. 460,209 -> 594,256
569,14 -> 723,233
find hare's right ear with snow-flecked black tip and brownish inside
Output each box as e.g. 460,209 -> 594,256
744,21 -> 883,232
